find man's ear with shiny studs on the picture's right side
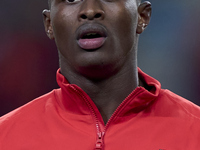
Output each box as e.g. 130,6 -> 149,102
136,1 -> 152,34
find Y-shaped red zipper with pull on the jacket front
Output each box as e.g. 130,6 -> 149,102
70,86 -> 142,150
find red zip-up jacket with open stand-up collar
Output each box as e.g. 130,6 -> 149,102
0,69 -> 200,150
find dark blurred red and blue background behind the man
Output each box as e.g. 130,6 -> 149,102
0,0 -> 200,116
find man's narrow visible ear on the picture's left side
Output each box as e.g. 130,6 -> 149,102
42,9 -> 54,39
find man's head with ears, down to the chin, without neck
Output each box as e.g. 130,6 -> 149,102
43,0 -> 151,79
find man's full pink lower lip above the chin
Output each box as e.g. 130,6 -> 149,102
78,37 -> 106,50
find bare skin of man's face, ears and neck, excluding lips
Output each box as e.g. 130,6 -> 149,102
43,0 -> 151,123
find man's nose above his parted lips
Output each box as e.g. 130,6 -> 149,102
78,0 -> 105,21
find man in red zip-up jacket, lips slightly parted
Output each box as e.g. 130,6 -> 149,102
0,0 -> 200,150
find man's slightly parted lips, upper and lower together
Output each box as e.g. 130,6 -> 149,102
76,23 -> 107,50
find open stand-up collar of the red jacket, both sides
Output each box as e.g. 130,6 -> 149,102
57,68 -> 161,118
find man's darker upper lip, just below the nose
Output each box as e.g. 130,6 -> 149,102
76,23 -> 107,40
